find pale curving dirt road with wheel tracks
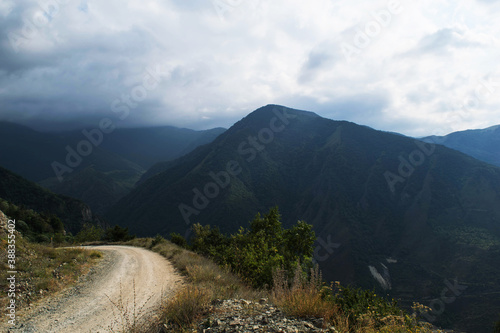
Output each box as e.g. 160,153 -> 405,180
6,246 -> 181,333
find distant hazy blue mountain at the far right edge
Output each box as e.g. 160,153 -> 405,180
422,125 -> 500,166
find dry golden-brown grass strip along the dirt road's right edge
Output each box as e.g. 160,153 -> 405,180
126,238 -> 433,333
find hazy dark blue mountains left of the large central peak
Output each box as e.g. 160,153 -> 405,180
0,122 -> 224,214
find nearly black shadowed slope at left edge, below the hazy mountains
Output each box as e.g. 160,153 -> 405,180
0,167 -> 100,234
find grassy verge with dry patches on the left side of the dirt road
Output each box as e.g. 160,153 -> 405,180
0,230 -> 101,308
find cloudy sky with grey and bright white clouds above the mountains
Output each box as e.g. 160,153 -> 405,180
0,0 -> 500,136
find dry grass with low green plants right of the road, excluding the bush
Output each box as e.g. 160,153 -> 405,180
123,237 -> 441,333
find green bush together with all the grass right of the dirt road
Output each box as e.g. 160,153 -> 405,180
127,208 -> 438,333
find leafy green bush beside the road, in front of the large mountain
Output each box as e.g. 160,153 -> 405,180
192,207 -> 316,288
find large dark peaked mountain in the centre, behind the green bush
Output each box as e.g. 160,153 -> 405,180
107,105 -> 500,332
